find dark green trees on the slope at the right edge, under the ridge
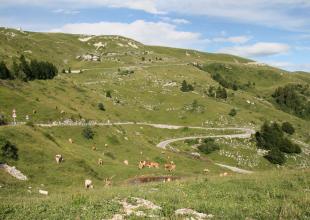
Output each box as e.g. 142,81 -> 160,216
272,84 -> 310,119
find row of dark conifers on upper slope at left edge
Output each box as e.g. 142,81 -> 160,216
0,55 -> 58,81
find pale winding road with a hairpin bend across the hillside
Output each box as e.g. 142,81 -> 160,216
9,120 -> 255,174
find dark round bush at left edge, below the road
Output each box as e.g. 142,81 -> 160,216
0,137 -> 18,162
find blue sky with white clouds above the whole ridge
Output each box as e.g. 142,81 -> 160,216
0,0 -> 310,72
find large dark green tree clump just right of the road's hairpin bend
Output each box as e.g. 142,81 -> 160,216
255,122 -> 301,165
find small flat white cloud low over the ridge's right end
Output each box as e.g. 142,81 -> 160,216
218,42 -> 290,57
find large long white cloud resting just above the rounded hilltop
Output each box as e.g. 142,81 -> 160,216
50,20 -> 207,48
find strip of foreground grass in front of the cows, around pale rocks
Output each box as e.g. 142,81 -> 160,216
0,169 -> 310,219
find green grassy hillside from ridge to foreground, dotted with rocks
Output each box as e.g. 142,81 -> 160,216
0,28 -> 310,219
